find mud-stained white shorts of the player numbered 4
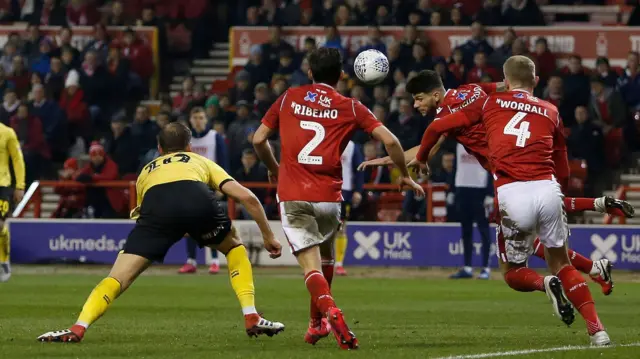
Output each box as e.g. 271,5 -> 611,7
496,180 -> 569,263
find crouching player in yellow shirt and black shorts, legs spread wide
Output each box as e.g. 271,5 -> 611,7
38,123 -> 284,342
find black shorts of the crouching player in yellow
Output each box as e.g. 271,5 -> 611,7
123,181 -> 231,262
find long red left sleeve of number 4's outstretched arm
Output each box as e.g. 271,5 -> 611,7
416,96 -> 486,163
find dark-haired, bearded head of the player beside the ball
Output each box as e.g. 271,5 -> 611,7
405,70 -> 445,116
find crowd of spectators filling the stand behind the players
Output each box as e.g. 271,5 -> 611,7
0,0 -> 640,219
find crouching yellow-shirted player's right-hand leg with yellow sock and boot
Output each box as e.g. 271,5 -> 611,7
209,226 -> 284,336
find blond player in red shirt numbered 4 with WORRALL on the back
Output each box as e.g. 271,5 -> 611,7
415,56 -> 611,346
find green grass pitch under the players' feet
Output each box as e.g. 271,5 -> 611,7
0,267 -> 640,359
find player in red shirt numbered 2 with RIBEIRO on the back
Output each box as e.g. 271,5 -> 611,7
253,48 -> 424,349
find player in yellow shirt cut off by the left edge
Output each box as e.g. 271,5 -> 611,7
0,123 -> 24,282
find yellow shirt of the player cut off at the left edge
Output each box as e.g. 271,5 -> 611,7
0,123 -> 25,189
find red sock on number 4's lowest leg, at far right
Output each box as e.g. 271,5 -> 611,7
557,266 -> 604,335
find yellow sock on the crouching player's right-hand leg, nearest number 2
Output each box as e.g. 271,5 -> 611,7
227,246 -> 257,315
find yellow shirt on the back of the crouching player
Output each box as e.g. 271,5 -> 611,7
131,152 -> 233,219
